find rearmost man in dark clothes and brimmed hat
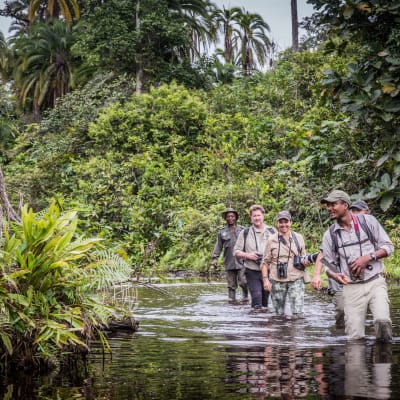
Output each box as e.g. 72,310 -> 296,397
212,208 -> 248,302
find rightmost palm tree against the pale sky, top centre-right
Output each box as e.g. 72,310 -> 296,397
237,8 -> 271,75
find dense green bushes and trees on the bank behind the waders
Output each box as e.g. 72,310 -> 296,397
3,0 -> 400,282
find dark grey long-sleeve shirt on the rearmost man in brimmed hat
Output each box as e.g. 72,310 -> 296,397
212,225 -> 244,270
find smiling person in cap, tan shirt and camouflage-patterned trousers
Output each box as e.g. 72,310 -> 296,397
261,210 -> 308,317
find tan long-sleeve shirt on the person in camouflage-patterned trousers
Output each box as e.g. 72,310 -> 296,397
263,231 -> 306,282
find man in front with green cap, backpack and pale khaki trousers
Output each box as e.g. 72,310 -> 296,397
321,190 -> 394,341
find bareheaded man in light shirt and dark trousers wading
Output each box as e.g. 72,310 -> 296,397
233,204 -> 275,312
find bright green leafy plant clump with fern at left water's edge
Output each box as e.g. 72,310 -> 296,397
0,204 -> 130,367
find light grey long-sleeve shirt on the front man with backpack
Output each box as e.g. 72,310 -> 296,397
322,214 -> 394,280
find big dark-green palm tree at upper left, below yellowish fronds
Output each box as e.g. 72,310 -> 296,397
11,20 -> 74,121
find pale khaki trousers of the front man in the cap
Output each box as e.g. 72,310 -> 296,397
343,276 -> 391,340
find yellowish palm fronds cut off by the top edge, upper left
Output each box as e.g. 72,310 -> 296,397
28,0 -> 80,25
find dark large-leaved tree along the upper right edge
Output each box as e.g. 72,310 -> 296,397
309,0 -> 400,210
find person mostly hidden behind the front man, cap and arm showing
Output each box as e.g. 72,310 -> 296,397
311,200 -> 370,329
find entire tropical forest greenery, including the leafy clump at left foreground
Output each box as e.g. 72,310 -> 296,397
0,0 -> 400,378
